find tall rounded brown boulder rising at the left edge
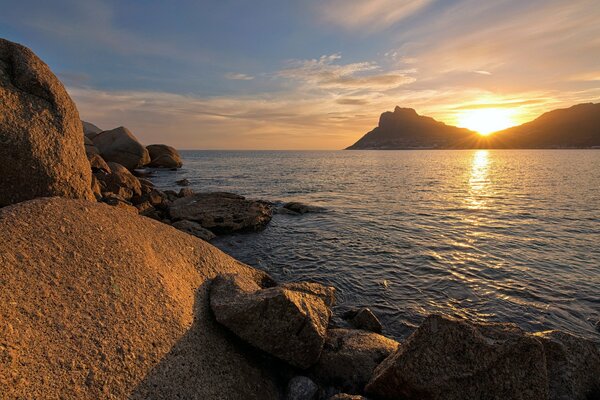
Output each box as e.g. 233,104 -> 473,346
0,39 -> 94,207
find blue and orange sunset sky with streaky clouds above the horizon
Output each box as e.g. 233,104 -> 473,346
0,0 -> 600,149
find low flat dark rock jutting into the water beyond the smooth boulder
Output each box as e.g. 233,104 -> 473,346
169,192 -> 272,234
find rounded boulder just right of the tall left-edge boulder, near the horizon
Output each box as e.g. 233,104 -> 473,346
92,126 -> 150,171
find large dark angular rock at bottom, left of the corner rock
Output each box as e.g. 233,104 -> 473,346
366,315 -> 548,400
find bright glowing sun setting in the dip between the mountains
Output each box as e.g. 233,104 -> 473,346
458,108 -> 516,136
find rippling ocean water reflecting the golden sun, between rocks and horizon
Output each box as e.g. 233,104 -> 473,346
152,150 -> 600,341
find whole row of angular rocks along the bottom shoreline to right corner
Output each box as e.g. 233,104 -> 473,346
210,274 -> 600,400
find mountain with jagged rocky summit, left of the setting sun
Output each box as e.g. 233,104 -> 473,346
347,107 -> 479,150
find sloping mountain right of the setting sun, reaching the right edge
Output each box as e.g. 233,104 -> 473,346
490,103 -> 600,149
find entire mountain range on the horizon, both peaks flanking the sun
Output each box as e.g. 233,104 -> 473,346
347,103 -> 600,150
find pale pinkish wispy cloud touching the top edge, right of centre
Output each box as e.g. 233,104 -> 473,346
318,0 -> 432,31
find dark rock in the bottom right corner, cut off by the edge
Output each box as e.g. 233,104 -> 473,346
534,331 -> 600,400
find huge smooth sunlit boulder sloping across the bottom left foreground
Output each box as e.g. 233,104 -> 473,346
0,198 -> 282,399
